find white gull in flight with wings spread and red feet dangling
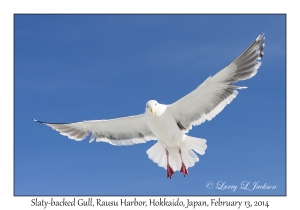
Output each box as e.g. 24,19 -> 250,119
33,33 -> 265,179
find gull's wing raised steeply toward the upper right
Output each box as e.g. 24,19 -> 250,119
168,34 -> 265,132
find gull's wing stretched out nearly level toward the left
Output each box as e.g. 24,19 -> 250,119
34,114 -> 156,145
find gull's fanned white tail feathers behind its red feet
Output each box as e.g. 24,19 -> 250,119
146,136 -> 207,171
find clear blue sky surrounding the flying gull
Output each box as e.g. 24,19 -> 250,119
14,15 -> 286,195
